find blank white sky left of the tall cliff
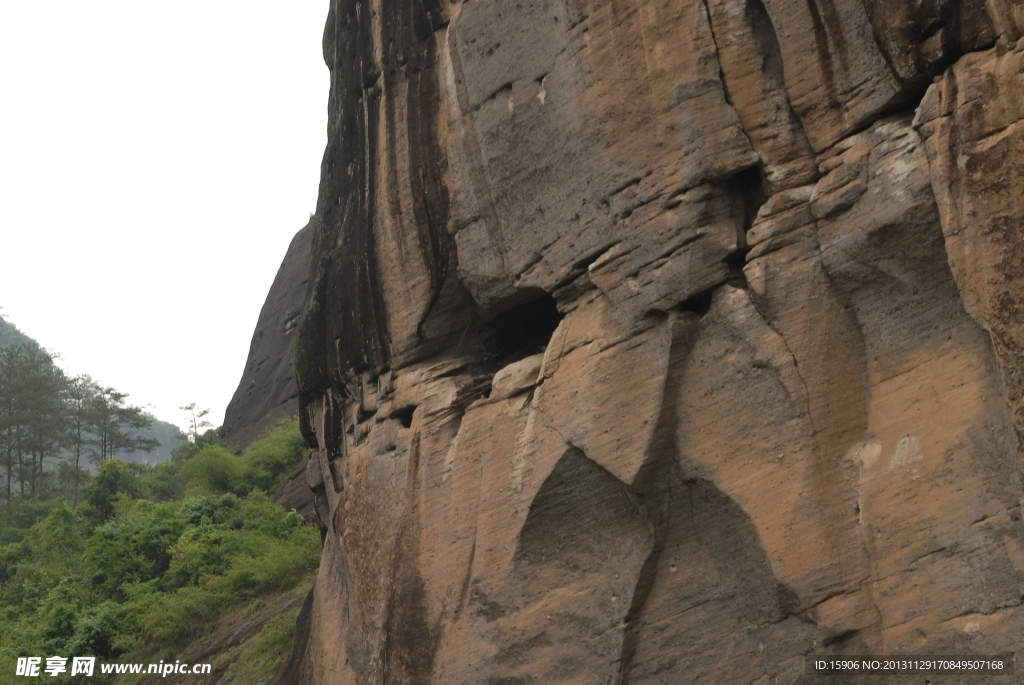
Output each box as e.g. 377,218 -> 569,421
0,0 -> 330,432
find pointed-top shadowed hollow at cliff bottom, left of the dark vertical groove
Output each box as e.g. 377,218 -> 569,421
473,446 -> 653,684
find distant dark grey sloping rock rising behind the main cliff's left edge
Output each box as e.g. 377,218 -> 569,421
221,224 -> 313,448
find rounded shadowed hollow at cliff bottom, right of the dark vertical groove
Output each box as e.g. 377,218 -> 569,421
618,475 -> 813,685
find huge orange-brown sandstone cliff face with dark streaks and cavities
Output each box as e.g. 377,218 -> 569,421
292,0 -> 1024,685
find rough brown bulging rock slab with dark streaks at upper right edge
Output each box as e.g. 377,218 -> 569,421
916,37 -> 1024,464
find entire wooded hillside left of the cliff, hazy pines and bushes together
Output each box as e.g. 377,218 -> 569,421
0,317 -> 319,683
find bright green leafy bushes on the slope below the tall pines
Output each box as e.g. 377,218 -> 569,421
0,419 -> 319,683
